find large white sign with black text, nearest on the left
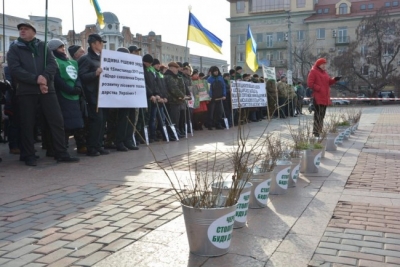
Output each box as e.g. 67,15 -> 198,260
98,49 -> 147,108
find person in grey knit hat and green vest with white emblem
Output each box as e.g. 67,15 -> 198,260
48,39 -> 86,154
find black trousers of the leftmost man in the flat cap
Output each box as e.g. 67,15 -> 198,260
18,94 -> 69,159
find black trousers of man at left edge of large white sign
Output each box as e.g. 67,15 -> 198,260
86,104 -> 108,150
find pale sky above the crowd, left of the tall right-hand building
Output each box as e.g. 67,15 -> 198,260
4,0 -> 230,62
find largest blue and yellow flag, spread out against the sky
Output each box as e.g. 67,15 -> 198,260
187,12 -> 222,54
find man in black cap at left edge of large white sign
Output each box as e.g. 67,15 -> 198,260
78,34 -> 110,157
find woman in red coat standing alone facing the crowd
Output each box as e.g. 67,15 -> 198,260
307,58 -> 341,137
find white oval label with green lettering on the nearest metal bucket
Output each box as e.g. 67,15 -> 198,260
207,211 -> 235,249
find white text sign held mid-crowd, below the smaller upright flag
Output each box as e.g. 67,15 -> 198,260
231,81 -> 267,109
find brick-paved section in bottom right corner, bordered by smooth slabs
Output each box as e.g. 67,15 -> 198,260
309,202 -> 400,267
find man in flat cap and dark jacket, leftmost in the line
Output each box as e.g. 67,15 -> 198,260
7,23 -> 79,166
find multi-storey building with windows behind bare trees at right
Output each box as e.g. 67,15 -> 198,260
228,0 -> 400,81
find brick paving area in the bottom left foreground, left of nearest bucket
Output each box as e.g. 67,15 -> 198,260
0,184 -> 181,267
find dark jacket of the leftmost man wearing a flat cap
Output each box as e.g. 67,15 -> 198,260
7,39 -> 58,95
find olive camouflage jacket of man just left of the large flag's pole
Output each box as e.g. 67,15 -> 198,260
164,70 -> 186,104
